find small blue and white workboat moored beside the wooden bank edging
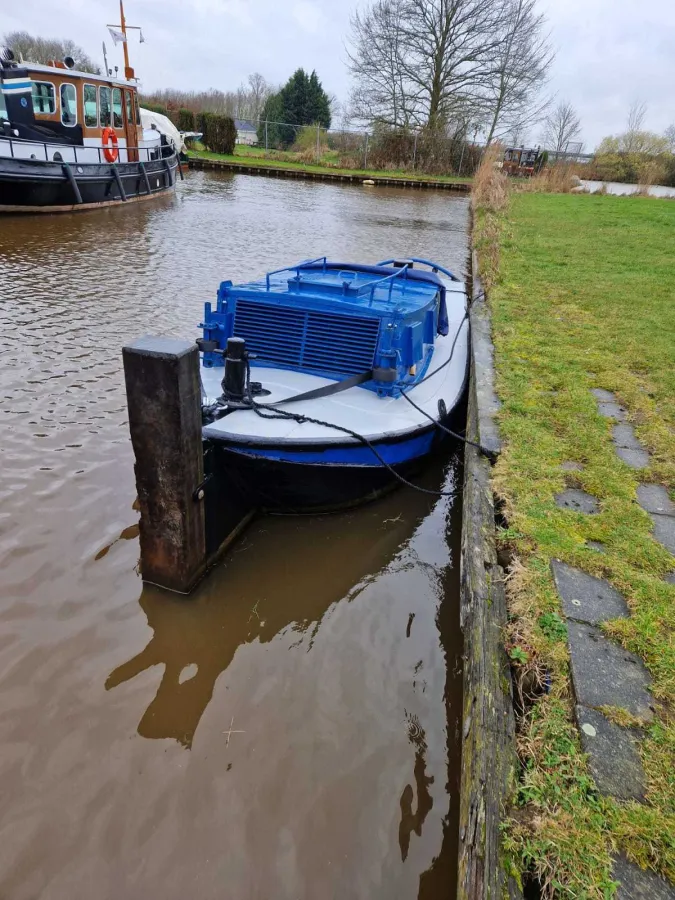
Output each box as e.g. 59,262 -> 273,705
199,257 -> 469,512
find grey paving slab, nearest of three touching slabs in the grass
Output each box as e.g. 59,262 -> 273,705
575,706 -> 645,800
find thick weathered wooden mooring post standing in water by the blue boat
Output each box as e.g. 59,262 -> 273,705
122,337 -> 207,593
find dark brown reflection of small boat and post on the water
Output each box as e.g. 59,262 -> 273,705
106,478 -> 444,749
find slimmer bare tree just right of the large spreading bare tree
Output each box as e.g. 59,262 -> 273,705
484,0 -> 555,145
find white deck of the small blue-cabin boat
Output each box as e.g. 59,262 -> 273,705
201,281 -> 469,445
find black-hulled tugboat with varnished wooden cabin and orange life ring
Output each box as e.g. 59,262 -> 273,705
0,3 -> 182,213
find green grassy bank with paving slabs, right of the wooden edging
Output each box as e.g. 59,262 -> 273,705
475,185 -> 675,898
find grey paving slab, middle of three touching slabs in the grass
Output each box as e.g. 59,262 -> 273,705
567,621 -> 653,722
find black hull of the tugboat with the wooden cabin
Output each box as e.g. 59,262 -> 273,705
0,153 -> 178,213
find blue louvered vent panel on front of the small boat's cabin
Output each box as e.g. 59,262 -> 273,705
234,300 -> 380,375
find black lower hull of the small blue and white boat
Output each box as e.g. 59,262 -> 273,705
207,400 -> 466,514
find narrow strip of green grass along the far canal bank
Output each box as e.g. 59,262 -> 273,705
188,144 -> 471,184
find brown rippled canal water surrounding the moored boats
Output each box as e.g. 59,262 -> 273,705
0,173 -> 468,900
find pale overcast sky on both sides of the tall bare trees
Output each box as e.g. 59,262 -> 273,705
5,0 -> 675,149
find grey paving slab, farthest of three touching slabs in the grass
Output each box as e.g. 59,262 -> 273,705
551,559 -> 628,625
